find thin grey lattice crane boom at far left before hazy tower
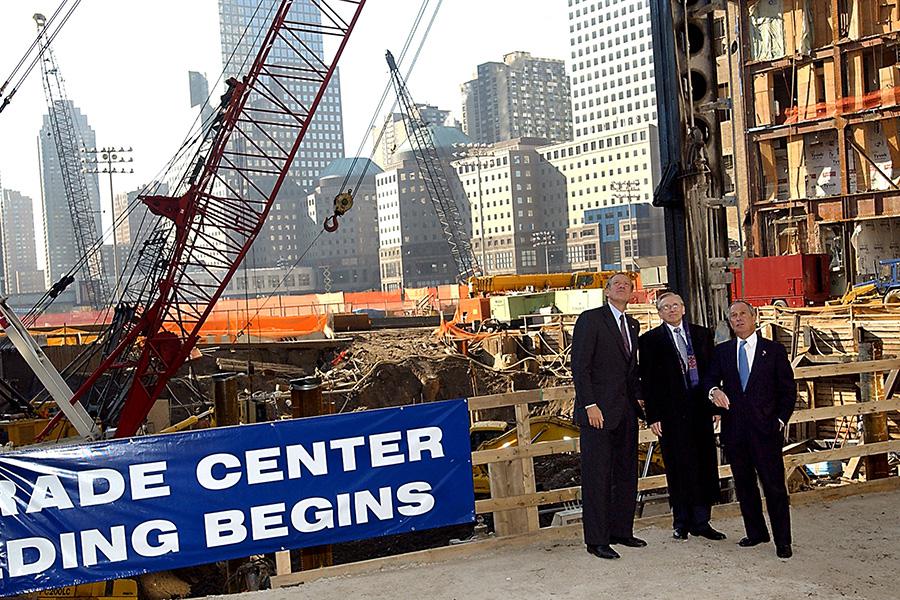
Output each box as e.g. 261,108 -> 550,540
34,13 -> 109,309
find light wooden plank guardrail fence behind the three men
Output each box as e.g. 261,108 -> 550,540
272,359 -> 900,587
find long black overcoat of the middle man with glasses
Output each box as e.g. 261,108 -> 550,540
639,323 -> 719,506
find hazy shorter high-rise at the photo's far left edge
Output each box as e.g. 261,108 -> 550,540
0,190 -> 44,294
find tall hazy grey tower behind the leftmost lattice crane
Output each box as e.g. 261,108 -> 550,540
38,100 -> 102,287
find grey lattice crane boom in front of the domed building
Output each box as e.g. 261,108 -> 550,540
385,51 -> 481,283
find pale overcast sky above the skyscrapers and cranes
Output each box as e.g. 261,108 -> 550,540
0,0 -> 569,263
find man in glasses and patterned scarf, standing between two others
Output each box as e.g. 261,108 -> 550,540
638,292 -> 725,540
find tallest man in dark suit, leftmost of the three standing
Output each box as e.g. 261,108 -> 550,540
572,273 -> 647,558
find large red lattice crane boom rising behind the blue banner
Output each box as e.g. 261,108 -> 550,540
19,0 -> 365,438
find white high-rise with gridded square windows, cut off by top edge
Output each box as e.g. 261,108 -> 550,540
569,0 -> 657,139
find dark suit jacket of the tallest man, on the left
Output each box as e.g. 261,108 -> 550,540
572,305 -> 643,429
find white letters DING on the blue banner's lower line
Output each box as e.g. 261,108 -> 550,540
0,511 -> 183,579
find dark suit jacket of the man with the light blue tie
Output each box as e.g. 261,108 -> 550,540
703,333 -> 797,444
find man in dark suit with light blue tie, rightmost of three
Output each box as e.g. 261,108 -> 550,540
704,300 -> 797,558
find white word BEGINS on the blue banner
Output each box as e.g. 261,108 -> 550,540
203,481 -> 434,548
